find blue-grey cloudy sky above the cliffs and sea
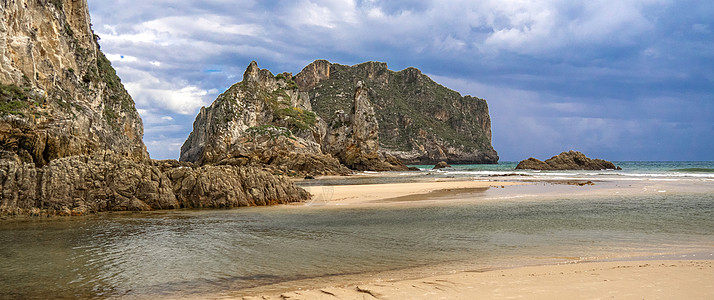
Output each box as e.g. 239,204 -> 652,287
89,0 -> 714,161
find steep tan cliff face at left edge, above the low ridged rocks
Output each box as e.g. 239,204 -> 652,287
0,0 -> 148,166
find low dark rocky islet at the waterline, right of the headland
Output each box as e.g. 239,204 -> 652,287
516,150 -> 621,170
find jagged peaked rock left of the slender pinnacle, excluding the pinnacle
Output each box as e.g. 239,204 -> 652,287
180,61 -> 349,175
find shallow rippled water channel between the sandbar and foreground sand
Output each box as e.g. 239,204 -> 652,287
0,191 -> 714,299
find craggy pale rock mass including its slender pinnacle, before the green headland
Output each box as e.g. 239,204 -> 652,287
180,62 -> 406,175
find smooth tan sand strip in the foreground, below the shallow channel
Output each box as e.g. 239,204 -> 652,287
238,258 -> 714,300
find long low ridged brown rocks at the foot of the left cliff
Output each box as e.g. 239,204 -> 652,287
0,152 -> 310,215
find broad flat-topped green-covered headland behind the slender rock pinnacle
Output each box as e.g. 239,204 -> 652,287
295,60 -> 498,164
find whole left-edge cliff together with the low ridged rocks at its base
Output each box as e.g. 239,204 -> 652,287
0,0 -> 312,215
